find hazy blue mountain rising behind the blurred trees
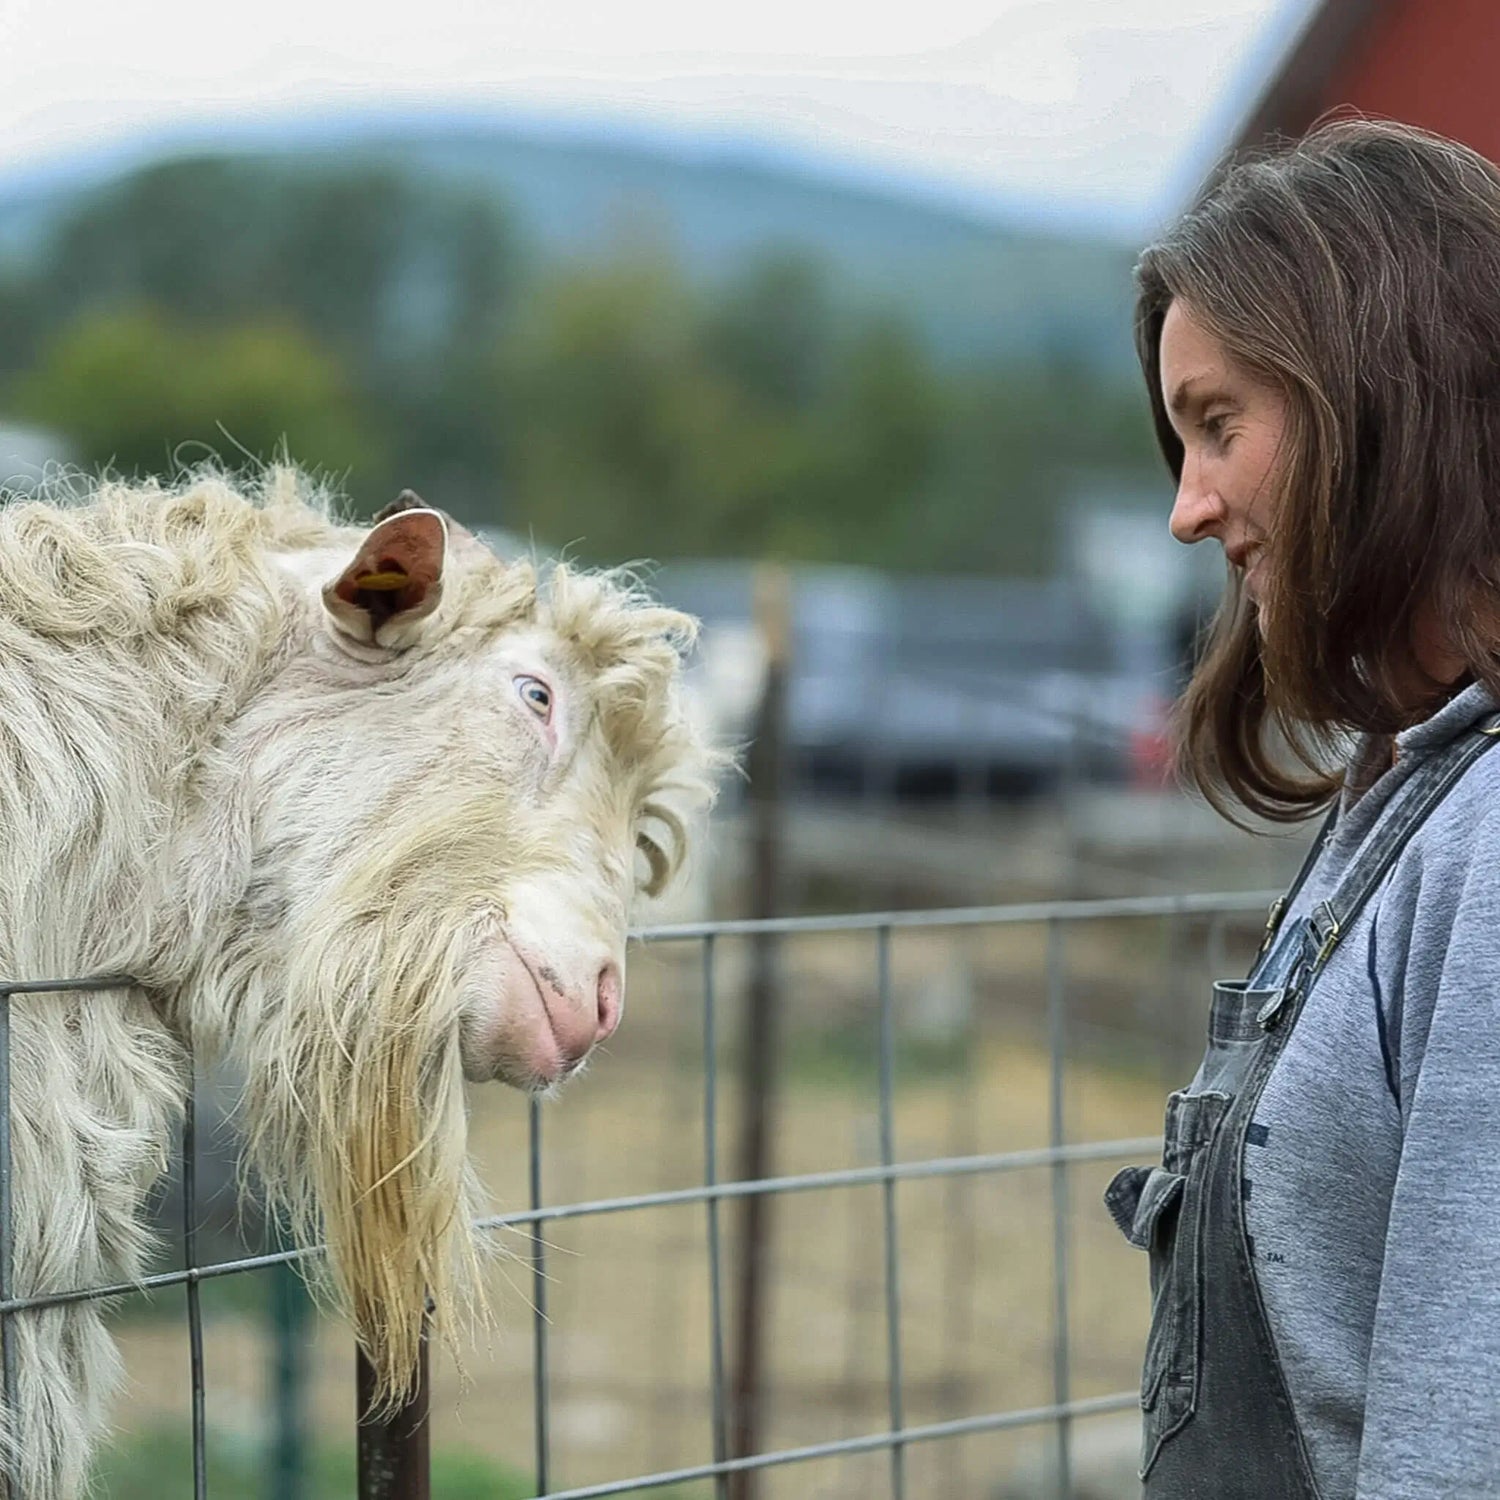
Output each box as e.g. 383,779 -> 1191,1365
0,113 -> 1131,371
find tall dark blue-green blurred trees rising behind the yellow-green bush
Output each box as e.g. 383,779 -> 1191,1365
19,156 -> 516,374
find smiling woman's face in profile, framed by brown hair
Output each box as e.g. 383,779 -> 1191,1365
1160,299 -> 1287,602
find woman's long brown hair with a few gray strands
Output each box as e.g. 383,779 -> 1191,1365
1136,120 -> 1500,821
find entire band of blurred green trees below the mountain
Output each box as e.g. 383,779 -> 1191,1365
0,158 -> 1158,572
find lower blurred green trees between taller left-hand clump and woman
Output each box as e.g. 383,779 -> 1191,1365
495,260 -> 1157,572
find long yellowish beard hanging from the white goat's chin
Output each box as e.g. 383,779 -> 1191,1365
234,893 -> 486,1412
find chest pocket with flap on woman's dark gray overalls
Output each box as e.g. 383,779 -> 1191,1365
1104,1092 -> 1230,1479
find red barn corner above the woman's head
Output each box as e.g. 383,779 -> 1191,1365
1235,0 -> 1500,162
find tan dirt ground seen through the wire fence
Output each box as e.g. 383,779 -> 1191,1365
96,900 -> 1254,1500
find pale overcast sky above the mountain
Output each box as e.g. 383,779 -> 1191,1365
0,0 -> 1311,227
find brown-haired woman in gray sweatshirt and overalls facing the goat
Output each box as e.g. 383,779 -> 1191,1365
1107,122 -> 1500,1500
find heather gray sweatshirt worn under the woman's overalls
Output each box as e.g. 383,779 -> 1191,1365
1218,686 -> 1500,1500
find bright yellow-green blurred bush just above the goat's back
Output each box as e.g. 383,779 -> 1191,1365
8,308 -> 381,489
